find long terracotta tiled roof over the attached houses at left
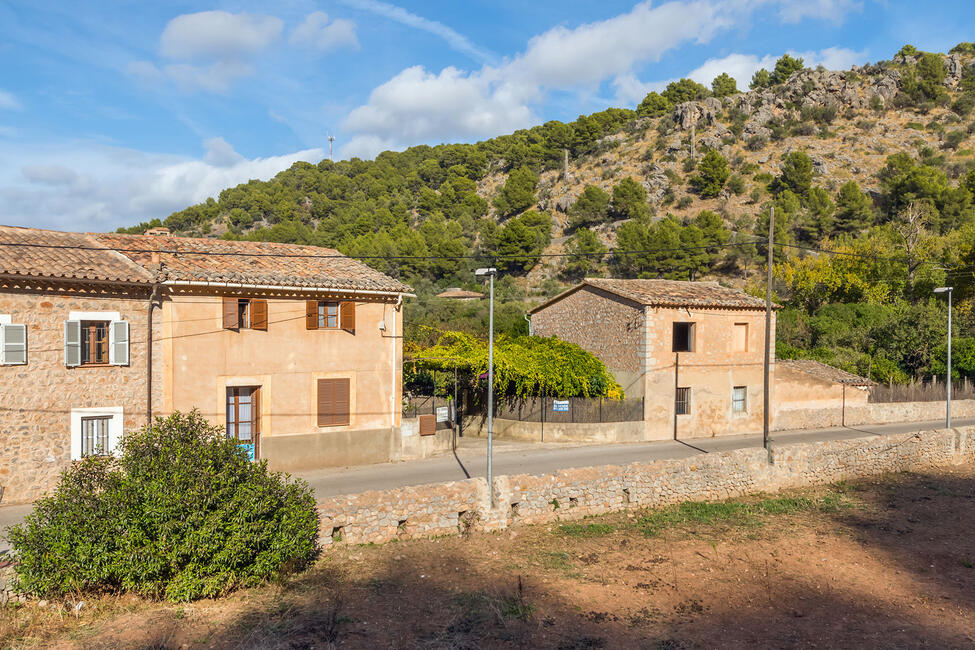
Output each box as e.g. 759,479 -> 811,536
0,226 -> 411,293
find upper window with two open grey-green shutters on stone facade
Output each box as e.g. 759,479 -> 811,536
64,312 -> 129,368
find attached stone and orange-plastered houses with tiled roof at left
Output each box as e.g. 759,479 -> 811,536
0,226 -> 410,504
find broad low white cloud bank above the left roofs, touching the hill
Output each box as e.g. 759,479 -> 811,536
0,138 -> 325,231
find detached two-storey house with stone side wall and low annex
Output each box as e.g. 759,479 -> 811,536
530,278 -> 866,440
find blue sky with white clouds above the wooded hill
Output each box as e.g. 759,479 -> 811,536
0,0 -> 975,230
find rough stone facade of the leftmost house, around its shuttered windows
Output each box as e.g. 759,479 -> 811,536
0,284 -> 163,505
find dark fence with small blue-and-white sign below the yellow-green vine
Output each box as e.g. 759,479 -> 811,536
465,397 -> 643,424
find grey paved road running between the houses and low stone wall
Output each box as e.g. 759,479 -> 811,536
0,418 -> 975,552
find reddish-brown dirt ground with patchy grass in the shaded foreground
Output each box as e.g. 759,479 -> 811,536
0,467 -> 975,649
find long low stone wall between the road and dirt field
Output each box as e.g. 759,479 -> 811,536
318,427 -> 975,544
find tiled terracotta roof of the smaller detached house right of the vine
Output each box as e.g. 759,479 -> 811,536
583,278 -> 777,309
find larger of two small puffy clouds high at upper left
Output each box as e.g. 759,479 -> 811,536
159,11 -> 283,60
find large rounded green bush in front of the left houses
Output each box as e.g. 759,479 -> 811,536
8,411 -> 318,602
